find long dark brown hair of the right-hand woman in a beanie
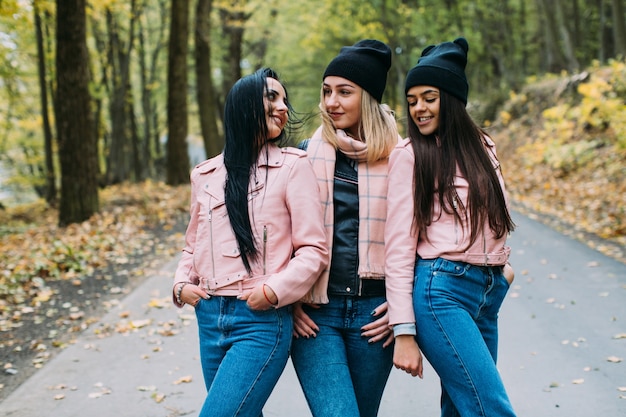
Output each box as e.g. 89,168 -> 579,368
407,89 -> 515,249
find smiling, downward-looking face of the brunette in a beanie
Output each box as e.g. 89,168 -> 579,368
406,85 -> 441,136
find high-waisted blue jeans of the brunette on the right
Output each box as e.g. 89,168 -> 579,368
413,258 -> 515,417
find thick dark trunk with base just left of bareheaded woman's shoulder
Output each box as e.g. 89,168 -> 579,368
167,0 -> 189,185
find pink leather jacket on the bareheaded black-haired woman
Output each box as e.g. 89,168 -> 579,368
173,144 -> 328,307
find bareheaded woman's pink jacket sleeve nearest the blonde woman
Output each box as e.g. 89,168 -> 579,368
266,155 -> 329,307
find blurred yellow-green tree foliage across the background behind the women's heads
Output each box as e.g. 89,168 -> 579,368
0,0 -> 626,205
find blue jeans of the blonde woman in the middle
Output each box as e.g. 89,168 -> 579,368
291,296 -> 393,417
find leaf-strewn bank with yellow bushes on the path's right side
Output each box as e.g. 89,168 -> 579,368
493,56 -> 626,244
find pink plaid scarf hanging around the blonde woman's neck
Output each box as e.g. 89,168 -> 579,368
302,128 -> 389,304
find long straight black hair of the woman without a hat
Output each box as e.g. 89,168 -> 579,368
224,68 -> 292,273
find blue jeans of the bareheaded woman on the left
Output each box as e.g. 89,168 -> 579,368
196,297 -> 293,417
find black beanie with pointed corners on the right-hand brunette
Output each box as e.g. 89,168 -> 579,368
404,38 -> 469,104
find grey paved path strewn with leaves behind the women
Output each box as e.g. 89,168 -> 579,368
0,216 -> 626,417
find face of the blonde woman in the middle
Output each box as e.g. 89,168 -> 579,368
322,75 -> 363,135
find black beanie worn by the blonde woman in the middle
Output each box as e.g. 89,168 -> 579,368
322,39 -> 391,103
